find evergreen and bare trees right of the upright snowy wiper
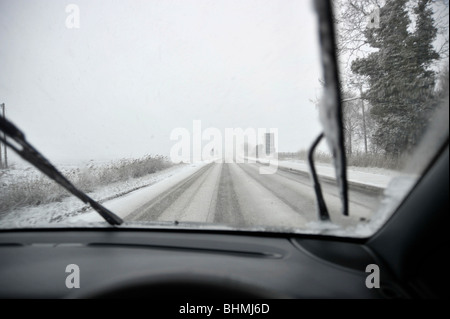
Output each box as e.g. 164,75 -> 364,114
334,0 -> 449,157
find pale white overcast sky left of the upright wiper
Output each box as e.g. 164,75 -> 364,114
0,0 -> 322,161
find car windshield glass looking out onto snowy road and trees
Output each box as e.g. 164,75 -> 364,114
0,0 -> 448,237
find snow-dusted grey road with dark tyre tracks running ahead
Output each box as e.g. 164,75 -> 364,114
125,163 -> 379,228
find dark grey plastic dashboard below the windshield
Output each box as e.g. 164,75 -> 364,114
0,229 -> 405,299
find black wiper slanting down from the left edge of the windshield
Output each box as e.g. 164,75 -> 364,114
0,117 -> 123,225
